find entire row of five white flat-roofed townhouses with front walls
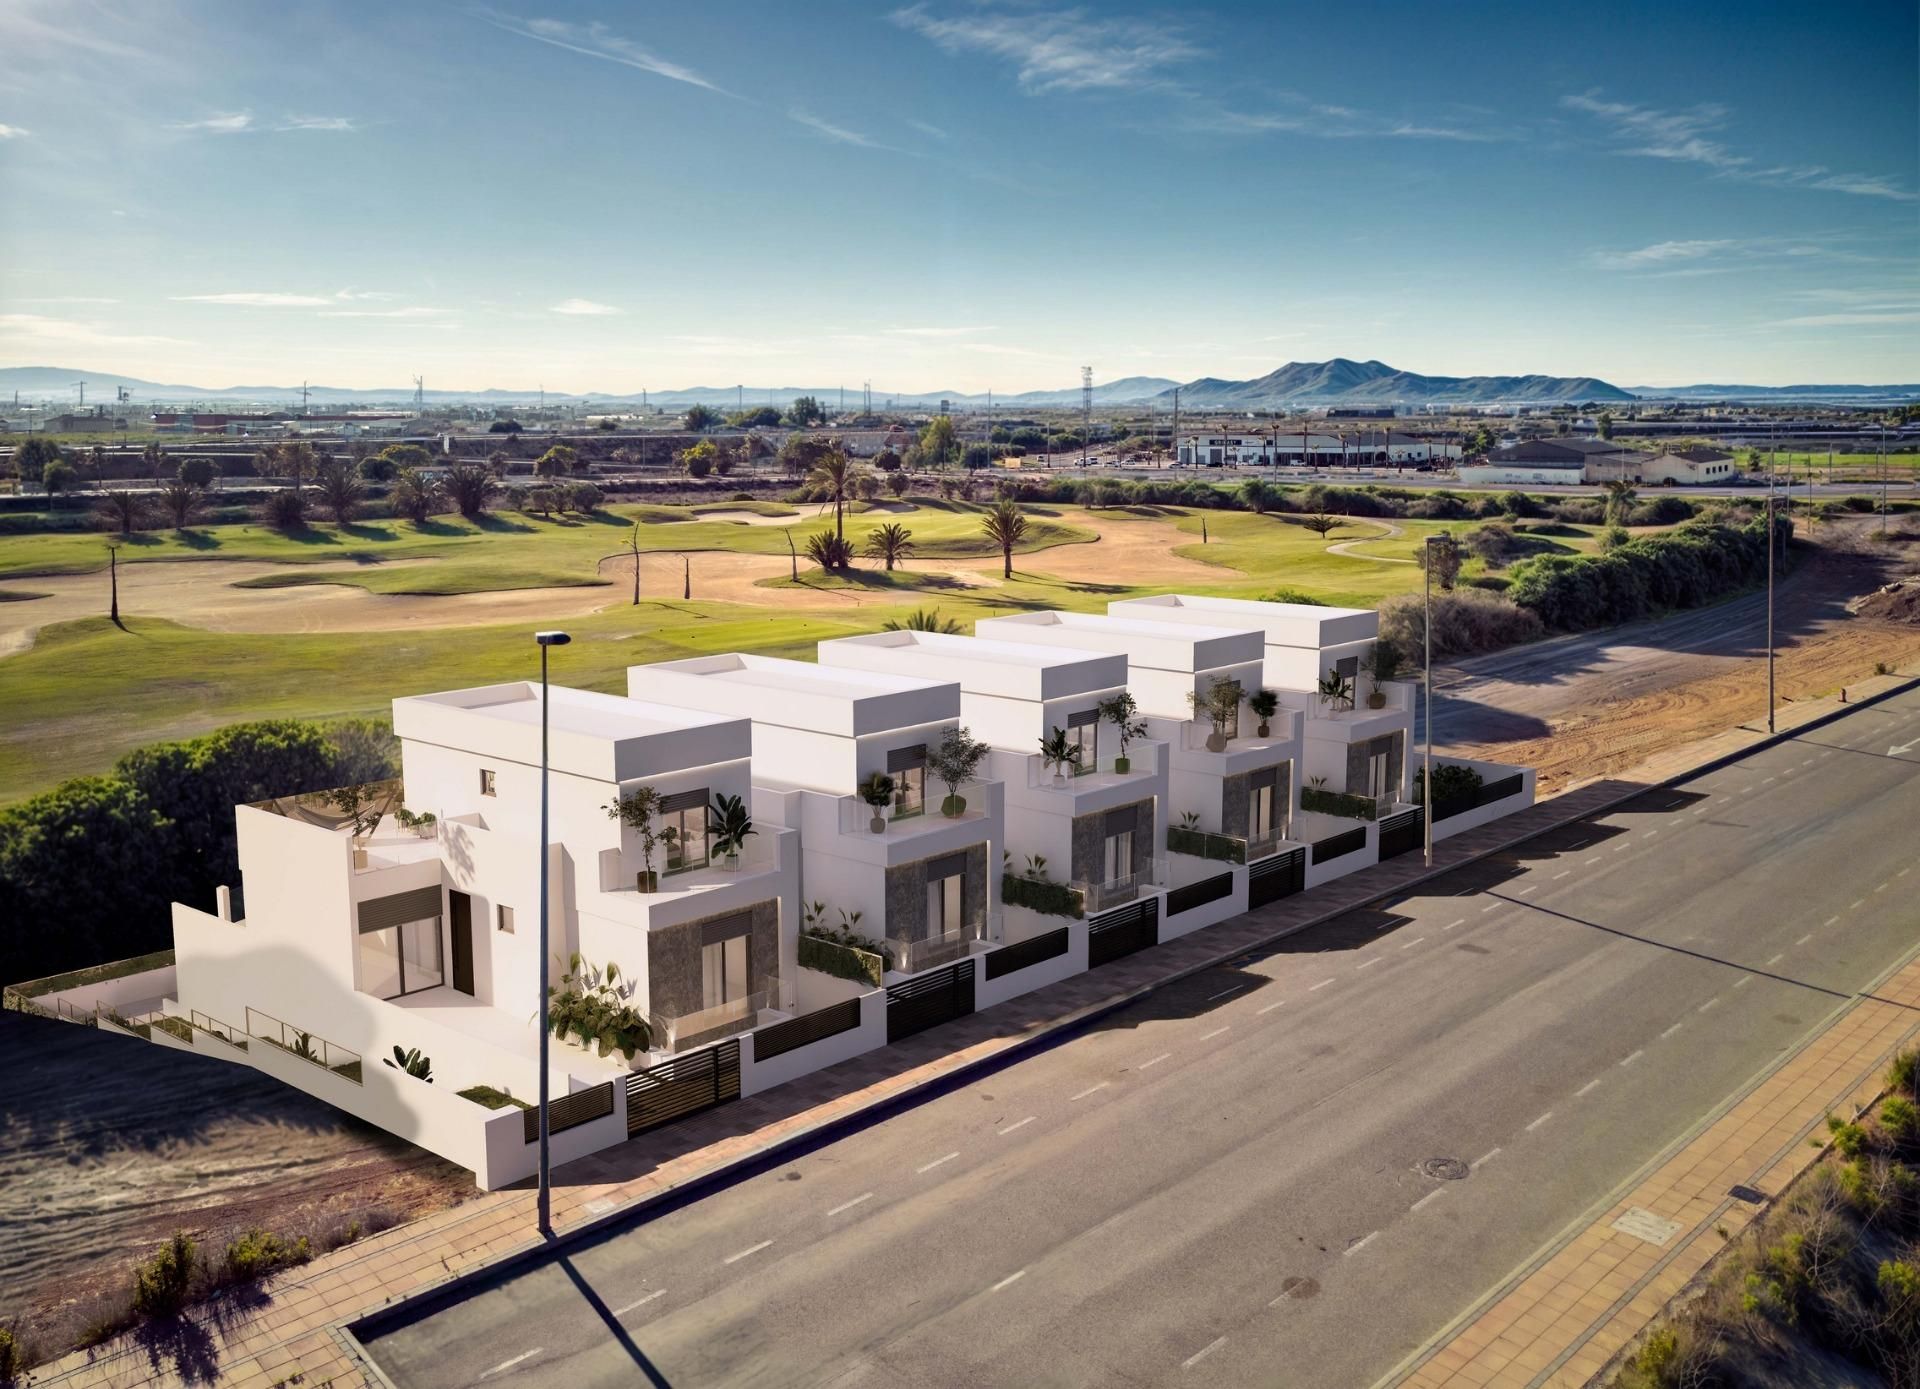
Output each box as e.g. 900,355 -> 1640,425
45,596 -> 1534,1187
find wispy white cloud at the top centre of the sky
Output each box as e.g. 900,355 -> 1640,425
889,4 -> 1202,92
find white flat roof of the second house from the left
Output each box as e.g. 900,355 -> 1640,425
626,651 -> 960,736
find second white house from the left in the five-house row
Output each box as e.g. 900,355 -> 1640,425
628,653 -> 1004,1003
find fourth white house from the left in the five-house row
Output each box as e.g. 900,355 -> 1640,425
973,613 -> 1302,938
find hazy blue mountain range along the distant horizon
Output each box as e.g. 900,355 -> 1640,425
0,357 -> 1920,411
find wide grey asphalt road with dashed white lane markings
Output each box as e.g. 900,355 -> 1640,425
372,694 -> 1920,1389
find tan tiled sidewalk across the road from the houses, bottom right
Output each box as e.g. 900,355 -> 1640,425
1388,963 -> 1920,1389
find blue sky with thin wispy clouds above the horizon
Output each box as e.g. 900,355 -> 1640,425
0,0 -> 1920,392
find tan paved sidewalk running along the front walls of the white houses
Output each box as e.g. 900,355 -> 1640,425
31,678 -> 1899,1389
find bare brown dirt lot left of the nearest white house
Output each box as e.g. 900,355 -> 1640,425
0,1012 -> 474,1360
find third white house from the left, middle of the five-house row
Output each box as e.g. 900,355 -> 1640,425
818,632 -> 1167,943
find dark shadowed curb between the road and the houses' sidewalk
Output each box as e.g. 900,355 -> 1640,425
332,676 -> 1920,1367
